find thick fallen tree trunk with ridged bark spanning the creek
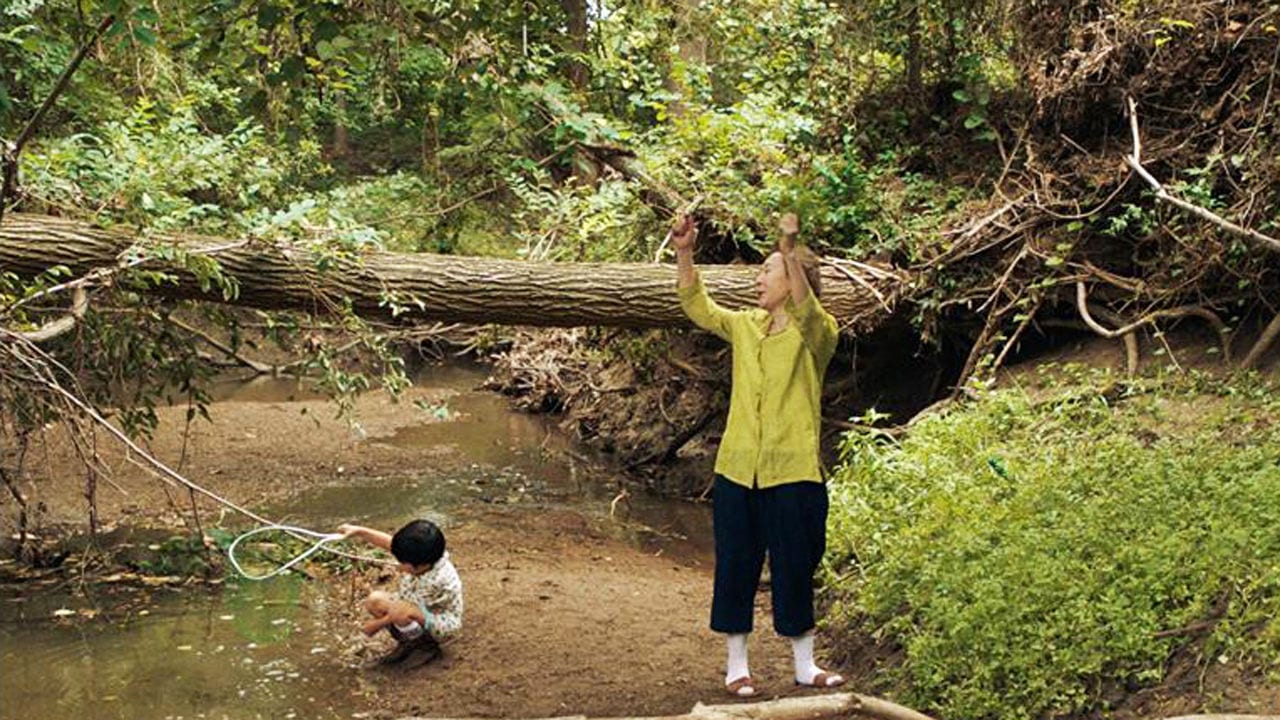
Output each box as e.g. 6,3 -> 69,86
0,213 -> 906,331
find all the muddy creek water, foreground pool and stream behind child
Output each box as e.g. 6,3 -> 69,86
0,366 -> 710,720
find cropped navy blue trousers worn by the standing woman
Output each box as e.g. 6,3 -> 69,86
712,475 -> 827,638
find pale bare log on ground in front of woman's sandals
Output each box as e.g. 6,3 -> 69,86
401,693 -> 932,720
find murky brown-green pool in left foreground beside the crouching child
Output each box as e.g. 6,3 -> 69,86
0,578 -> 355,719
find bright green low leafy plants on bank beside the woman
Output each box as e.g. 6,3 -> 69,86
828,369 -> 1280,719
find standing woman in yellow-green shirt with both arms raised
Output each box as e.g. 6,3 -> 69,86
672,214 -> 845,697
